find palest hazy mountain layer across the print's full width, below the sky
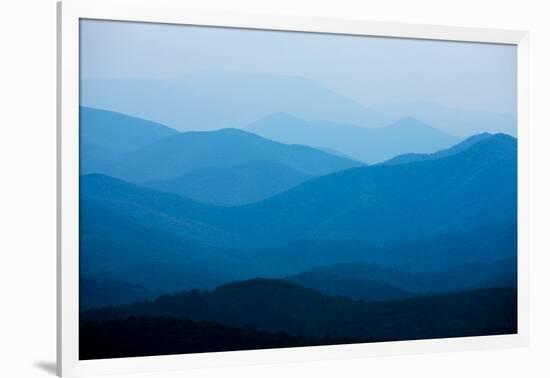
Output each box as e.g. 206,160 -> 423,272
80,71 -> 516,137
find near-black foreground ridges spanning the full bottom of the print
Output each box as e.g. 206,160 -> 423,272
80,279 -> 517,358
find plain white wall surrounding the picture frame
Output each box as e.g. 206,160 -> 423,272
0,0 -> 550,378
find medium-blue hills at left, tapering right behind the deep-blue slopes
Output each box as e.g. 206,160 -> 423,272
80,107 -> 354,206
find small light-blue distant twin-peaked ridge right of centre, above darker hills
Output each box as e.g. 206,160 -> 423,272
246,113 -> 460,163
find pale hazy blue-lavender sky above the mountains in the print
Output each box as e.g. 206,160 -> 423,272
81,20 -> 517,114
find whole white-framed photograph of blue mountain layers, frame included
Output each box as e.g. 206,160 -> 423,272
58,0 -> 529,376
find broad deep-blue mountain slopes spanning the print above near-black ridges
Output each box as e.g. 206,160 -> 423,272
80,135 -> 517,298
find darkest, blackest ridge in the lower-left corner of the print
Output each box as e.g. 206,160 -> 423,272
80,317 -> 360,360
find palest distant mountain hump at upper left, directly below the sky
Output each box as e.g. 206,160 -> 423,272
80,71 -> 390,131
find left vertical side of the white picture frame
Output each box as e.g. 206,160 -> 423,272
57,1 -> 80,377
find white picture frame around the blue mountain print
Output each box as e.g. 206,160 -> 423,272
57,0 -> 529,376
